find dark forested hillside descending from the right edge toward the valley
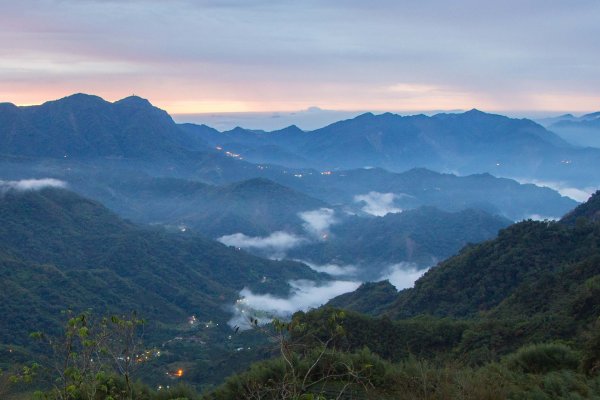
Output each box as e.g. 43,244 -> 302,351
326,193 -> 600,328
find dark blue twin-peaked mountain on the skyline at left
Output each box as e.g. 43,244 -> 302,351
0,93 -> 206,158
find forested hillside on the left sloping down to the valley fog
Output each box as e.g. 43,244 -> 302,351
0,189 -> 319,343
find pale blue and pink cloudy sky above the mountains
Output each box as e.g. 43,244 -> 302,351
0,0 -> 600,114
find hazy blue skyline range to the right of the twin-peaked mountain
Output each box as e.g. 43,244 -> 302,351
181,110 -> 600,184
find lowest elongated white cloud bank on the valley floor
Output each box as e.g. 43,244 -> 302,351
229,280 -> 360,328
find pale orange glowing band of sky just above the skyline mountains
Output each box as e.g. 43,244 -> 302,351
0,88 -> 600,115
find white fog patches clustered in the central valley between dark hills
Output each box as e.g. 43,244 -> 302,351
218,202 -> 426,329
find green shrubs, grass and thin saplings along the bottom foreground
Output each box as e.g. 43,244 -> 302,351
5,309 -> 600,400
